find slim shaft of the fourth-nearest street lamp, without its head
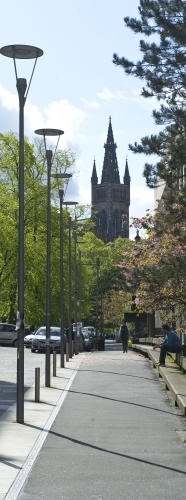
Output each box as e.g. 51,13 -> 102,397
68,216 -> 72,358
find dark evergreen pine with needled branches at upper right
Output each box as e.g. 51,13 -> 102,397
113,0 -> 186,187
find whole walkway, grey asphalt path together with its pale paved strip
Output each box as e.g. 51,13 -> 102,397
0,343 -> 186,500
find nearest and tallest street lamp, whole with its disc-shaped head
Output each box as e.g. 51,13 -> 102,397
0,45 -> 43,424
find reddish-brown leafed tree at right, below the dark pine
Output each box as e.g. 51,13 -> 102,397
117,201 -> 186,329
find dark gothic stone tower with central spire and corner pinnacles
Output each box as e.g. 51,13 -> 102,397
91,117 -> 130,243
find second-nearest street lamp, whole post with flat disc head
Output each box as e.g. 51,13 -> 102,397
35,128 -> 64,387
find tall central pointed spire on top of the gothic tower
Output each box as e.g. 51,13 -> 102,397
101,116 -> 120,184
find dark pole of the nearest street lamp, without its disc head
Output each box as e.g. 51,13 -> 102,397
16,78 -> 27,424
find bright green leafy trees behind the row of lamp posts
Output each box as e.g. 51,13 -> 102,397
0,133 -> 136,328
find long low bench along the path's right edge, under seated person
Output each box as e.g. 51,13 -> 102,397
132,344 -> 186,416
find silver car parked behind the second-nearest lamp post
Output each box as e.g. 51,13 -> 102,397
31,326 -> 67,352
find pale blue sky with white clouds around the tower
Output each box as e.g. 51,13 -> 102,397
0,0 -> 158,236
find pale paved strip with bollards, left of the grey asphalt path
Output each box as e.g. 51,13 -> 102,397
0,353 -> 86,500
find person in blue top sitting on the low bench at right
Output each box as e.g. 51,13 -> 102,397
153,324 -> 182,366
